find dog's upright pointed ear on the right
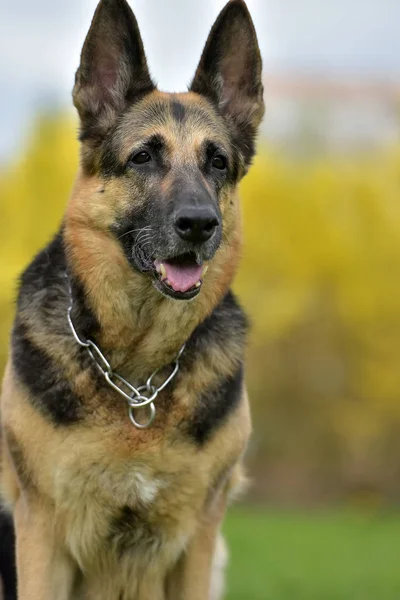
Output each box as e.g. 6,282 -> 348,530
190,0 -> 264,163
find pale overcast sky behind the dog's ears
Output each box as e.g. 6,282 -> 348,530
0,0 -> 400,159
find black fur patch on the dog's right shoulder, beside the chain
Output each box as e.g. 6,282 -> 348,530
187,365 -> 243,446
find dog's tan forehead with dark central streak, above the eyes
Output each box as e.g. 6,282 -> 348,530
115,91 -> 231,158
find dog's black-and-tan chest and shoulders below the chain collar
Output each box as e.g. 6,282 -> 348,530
4,232 -> 249,570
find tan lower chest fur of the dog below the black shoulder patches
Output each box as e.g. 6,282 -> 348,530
13,390 -> 248,573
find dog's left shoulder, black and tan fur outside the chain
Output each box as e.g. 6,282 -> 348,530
11,232 -> 86,424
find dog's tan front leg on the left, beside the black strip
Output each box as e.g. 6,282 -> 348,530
14,496 -> 74,600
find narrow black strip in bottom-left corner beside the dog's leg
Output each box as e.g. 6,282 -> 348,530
0,506 -> 17,600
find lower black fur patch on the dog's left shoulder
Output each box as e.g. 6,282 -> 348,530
12,320 -> 81,425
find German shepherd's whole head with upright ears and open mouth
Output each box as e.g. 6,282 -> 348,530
69,0 -> 264,299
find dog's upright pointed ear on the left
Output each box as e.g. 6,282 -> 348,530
73,0 -> 155,137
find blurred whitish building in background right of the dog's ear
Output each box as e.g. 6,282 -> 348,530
263,74 -> 400,155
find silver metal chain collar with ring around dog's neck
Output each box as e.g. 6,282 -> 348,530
67,278 -> 186,429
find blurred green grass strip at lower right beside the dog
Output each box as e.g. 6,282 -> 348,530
224,511 -> 400,600
